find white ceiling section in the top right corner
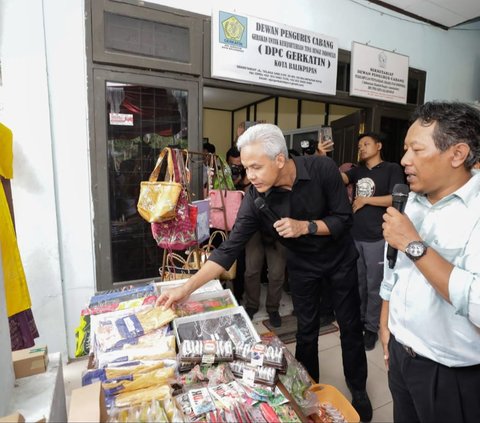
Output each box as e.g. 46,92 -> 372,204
373,0 -> 480,28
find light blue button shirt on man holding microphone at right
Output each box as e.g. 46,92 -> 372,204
380,172 -> 480,367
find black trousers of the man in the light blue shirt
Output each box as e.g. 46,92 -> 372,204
388,335 -> 480,423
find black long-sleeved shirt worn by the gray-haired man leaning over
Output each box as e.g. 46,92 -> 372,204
210,156 -> 356,271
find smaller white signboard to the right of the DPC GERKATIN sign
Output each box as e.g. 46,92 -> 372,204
350,42 -> 408,104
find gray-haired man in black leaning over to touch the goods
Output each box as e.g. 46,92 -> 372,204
157,124 -> 372,422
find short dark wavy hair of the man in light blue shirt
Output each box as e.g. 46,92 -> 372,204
411,101 -> 480,169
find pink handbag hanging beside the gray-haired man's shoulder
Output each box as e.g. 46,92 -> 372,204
208,155 -> 245,231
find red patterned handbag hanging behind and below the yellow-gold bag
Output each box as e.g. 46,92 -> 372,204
151,149 -> 198,251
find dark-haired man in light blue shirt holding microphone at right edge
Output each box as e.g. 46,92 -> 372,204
380,102 -> 480,422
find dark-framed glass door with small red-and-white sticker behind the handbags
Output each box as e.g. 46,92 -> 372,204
92,69 -> 200,290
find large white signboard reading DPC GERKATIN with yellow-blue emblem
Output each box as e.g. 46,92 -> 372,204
212,10 -> 338,95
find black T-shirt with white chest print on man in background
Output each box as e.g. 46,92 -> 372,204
345,162 -> 405,242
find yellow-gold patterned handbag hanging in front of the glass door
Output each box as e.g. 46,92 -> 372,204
137,147 -> 182,223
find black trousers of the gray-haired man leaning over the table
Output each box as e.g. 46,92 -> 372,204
289,253 -> 367,390
